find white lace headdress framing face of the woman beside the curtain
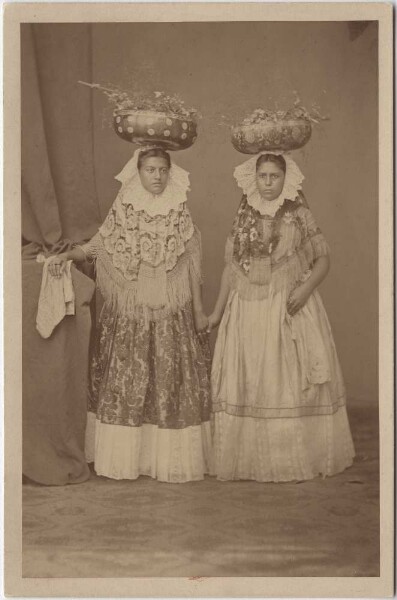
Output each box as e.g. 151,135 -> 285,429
115,146 -> 190,217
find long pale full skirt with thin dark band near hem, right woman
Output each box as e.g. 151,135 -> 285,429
212,288 -> 354,482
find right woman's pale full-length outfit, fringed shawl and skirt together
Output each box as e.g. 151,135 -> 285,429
212,196 -> 354,481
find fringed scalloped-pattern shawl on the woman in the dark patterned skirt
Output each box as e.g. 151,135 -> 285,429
82,201 -> 201,320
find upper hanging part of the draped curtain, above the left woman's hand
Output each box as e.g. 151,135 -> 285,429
21,24 -> 100,247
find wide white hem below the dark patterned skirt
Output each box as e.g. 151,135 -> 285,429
86,413 -> 211,483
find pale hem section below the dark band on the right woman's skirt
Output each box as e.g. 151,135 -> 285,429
213,407 -> 354,482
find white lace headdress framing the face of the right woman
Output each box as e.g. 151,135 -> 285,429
234,150 -> 304,217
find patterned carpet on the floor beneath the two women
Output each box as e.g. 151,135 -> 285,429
23,406 -> 379,577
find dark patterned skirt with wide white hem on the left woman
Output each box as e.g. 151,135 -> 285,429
87,303 -> 211,481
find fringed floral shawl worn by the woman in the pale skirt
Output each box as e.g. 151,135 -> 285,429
225,196 -> 329,300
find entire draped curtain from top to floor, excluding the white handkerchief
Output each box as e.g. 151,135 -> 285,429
21,24 -> 100,485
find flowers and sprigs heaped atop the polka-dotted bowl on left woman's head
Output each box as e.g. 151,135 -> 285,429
78,81 -> 201,122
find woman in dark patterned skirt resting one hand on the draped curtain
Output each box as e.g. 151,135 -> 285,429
52,148 -> 211,482
